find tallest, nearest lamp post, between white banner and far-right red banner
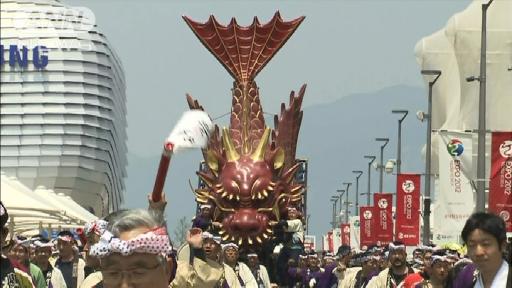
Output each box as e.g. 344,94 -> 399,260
466,0 -> 493,212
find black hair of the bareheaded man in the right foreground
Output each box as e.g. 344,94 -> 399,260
461,212 -> 507,246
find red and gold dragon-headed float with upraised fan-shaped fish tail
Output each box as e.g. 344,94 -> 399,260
183,12 -> 306,247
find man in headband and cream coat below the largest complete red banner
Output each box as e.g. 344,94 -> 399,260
366,241 -> 416,288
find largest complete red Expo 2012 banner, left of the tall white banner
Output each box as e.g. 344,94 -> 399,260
395,174 -> 421,246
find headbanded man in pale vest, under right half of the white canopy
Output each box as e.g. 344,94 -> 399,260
55,230 -> 85,288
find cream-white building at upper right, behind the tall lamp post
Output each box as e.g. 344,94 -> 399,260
414,0 -> 512,179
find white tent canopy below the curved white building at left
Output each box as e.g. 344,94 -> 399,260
1,174 -> 97,234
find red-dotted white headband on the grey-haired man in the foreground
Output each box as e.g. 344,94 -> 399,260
90,227 -> 173,258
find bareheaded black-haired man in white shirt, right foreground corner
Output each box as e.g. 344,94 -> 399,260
461,212 -> 512,288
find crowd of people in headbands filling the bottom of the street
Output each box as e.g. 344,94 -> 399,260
0,198 -> 512,288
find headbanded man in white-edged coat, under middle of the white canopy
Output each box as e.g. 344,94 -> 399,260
33,238 -> 66,288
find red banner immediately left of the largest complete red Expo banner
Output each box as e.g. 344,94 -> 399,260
373,193 -> 393,245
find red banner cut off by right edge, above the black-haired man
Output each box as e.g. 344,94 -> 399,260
489,132 -> 512,232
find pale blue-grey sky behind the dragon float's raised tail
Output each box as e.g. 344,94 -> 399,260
64,0 -> 471,238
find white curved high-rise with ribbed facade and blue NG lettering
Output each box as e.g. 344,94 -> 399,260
0,0 -> 127,216
